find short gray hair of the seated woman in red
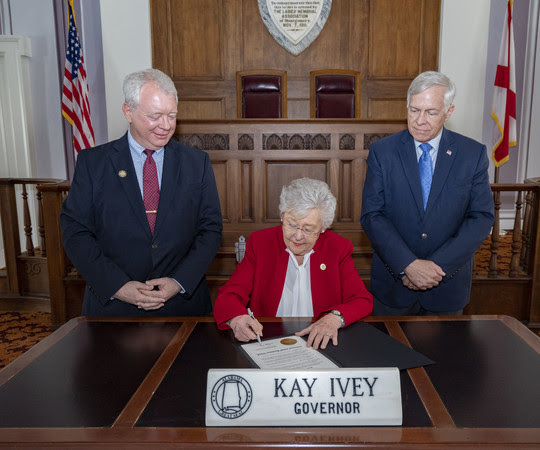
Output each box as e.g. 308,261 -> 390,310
279,178 -> 337,230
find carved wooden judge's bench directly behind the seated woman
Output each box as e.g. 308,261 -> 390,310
174,119 -> 407,289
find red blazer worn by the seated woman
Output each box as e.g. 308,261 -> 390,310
214,226 -> 373,329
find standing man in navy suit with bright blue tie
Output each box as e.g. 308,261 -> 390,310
361,72 -> 494,315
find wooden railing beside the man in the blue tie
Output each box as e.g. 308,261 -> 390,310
465,179 -> 540,327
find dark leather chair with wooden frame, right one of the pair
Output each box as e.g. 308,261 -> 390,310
310,69 -> 360,119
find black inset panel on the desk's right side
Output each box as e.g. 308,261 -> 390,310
401,320 -> 540,428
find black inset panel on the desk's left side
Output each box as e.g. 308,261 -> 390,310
0,322 -> 182,428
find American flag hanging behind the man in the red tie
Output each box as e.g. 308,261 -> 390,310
62,0 -> 95,153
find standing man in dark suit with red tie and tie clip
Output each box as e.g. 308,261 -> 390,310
60,69 -> 222,316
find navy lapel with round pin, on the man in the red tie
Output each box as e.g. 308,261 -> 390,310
110,134 -> 152,237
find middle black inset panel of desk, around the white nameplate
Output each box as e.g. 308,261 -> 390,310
136,321 -> 432,427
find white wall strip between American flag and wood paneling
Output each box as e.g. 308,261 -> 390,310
100,0 -> 152,140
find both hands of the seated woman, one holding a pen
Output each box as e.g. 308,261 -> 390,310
227,314 -> 341,350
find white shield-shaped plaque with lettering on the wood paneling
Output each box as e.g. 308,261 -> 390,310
258,0 -> 332,55
